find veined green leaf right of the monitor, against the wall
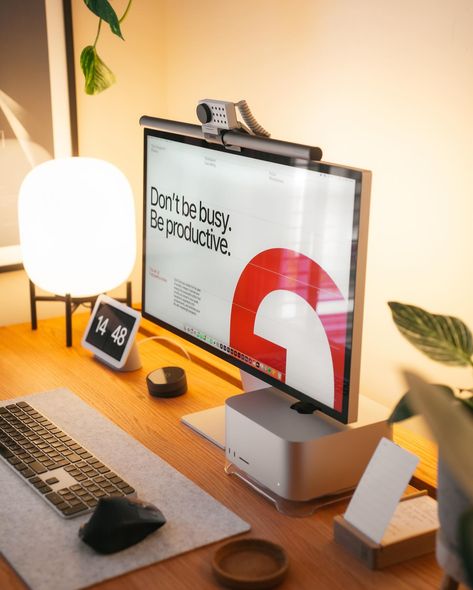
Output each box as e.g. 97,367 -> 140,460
388,301 -> 473,366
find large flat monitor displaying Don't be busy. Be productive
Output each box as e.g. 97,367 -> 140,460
142,129 -> 370,422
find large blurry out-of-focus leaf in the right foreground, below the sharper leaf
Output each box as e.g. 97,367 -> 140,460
404,371 -> 473,502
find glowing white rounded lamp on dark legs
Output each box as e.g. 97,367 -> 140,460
18,157 -> 136,346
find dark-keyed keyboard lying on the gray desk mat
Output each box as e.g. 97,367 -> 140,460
0,402 -> 136,518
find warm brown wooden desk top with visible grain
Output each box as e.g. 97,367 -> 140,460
0,315 -> 441,590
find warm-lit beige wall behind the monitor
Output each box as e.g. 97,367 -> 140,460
0,0 -> 473,416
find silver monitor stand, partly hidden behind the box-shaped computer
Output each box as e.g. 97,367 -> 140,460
181,369 -> 269,449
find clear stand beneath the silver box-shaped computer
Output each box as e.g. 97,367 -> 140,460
225,461 -> 354,516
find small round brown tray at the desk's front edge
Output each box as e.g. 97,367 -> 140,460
212,539 -> 289,590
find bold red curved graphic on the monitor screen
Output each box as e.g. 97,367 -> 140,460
230,248 -> 347,411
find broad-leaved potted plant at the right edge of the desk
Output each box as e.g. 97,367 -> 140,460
389,302 -> 473,588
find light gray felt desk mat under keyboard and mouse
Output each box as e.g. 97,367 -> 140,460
0,389 -> 250,590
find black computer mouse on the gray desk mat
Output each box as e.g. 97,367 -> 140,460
79,498 -> 166,554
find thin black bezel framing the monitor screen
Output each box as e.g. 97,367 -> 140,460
141,128 -> 364,424
